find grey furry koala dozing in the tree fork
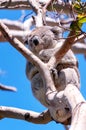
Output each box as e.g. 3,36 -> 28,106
26,26 -> 80,107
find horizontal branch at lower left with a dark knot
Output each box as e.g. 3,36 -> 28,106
0,106 -> 52,124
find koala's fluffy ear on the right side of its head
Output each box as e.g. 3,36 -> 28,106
51,26 -> 62,39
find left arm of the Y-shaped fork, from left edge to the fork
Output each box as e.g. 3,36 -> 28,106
0,22 -> 44,71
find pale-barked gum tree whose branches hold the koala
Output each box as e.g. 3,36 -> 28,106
0,0 -> 86,130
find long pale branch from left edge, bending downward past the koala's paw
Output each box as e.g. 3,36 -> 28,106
0,22 -> 56,96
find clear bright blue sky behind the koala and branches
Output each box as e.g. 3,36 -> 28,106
0,10 -> 86,130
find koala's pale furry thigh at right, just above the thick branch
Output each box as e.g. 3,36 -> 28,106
55,67 -> 80,91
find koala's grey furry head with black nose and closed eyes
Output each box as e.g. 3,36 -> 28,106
27,26 -> 59,54
